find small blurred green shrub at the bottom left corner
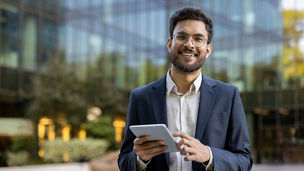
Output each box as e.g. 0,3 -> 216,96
7,151 -> 29,166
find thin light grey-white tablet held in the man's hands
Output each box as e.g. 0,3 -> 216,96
130,124 -> 179,152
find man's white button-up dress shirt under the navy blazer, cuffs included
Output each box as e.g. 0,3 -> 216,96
137,71 -> 213,171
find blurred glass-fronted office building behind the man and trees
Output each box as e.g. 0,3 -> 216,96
0,0 -> 304,163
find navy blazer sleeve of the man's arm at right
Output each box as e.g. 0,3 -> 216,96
210,88 -> 252,171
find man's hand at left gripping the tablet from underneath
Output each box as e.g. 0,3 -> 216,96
133,135 -> 168,161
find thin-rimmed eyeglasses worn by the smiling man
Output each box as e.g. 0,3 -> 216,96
173,32 -> 207,48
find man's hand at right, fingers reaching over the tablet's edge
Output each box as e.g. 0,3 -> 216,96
173,132 -> 210,163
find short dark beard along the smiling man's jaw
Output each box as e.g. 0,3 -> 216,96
169,49 -> 207,72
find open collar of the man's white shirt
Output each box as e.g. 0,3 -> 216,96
166,70 -> 202,95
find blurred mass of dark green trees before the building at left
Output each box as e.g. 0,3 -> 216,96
28,54 -> 129,136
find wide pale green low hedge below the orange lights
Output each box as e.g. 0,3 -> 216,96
42,138 -> 109,163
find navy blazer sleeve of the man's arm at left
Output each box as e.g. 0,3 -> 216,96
118,91 -> 138,171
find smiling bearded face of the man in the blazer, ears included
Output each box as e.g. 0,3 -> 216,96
167,20 -> 212,72
